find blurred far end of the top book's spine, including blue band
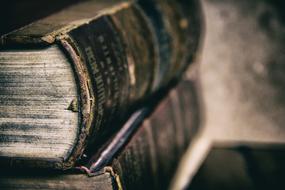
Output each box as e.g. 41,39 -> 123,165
138,0 -> 202,84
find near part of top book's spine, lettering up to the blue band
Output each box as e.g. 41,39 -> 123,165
61,4 -> 158,166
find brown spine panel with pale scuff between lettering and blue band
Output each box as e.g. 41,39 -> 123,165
111,4 -> 158,102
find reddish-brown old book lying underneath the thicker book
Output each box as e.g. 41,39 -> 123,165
0,78 -> 200,189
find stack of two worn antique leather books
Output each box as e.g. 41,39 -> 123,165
0,0 -> 202,189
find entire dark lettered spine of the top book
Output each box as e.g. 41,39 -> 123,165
60,1 -> 200,168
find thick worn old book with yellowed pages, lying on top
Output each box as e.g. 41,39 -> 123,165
0,0 -> 200,169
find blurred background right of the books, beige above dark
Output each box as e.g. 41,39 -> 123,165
184,0 -> 285,189
